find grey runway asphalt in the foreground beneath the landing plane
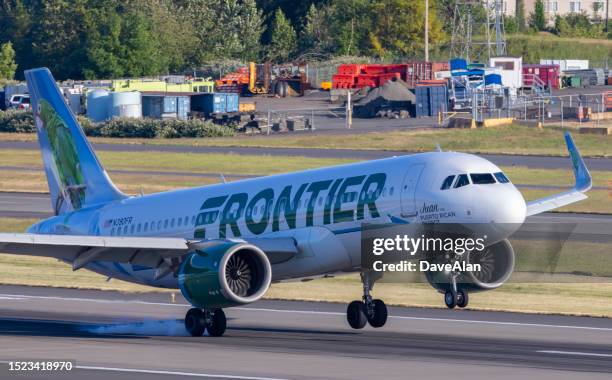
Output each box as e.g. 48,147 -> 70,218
0,286 -> 612,380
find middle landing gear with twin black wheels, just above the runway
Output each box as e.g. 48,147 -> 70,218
346,271 -> 387,329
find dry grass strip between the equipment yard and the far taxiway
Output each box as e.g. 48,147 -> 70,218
0,125 -> 612,157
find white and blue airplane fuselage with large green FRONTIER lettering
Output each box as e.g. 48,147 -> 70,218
29,152 -> 525,288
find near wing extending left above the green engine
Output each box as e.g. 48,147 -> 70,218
0,233 -> 298,277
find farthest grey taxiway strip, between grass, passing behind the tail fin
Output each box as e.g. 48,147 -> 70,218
0,141 -> 612,170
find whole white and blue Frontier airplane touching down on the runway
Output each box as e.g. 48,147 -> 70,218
0,68 -> 591,336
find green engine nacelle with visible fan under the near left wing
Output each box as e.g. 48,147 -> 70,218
178,242 -> 272,309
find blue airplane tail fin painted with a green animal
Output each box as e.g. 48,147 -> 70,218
25,68 -> 126,215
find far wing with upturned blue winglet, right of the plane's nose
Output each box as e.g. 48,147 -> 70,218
527,132 -> 593,216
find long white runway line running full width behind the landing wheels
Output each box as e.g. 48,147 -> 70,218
0,294 -> 612,331
